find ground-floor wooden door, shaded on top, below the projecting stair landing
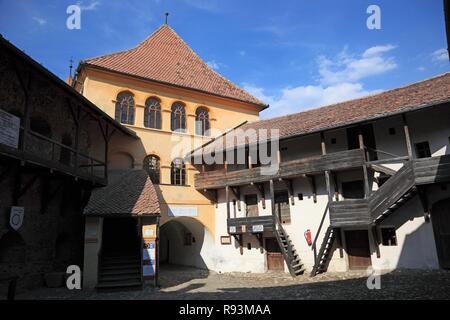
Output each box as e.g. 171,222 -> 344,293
345,230 -> 372,270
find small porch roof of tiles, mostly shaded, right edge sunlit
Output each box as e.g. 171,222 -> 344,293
84,170 -> 160,216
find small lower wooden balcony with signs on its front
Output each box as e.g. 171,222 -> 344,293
227,216 -> 275,235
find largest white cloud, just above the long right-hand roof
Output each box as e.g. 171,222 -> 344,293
244,45 -> 397,116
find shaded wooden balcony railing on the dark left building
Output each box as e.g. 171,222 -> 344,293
0,128 -> 107,186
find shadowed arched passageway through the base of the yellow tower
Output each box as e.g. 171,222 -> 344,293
159,217 -> 213,269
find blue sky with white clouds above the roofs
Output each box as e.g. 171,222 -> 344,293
0,0 -> 449,117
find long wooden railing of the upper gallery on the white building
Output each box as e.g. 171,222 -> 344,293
195,149 -> 364,190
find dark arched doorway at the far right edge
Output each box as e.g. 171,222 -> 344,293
431,199 -> 450,269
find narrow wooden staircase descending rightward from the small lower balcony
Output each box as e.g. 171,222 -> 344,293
274,215 -> 305,277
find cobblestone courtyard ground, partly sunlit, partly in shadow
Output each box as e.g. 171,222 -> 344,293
17,266 -> 450,300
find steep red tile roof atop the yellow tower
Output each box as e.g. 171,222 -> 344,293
81,25 -> 266,107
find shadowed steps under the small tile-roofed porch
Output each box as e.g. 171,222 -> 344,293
97,254 -> 143,290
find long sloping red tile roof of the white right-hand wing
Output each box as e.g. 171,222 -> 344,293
194,73 -> 450,155
